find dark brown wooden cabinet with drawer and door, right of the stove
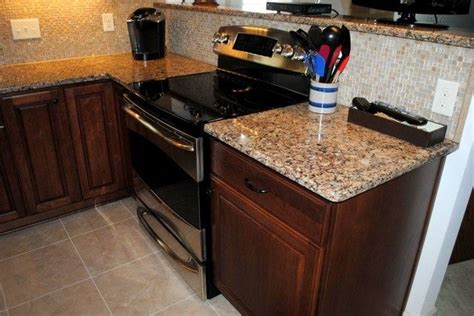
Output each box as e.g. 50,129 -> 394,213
210,140 -> 443,316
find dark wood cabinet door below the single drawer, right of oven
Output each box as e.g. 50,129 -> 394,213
211,176 -> 319,315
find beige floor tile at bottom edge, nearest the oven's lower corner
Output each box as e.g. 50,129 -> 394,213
95,255 -> 191,315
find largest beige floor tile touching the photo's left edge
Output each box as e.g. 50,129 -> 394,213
0,240 -> 88,307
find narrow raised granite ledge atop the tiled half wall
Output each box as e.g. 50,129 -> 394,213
154,0 -> 474,48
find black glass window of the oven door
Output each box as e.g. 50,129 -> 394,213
129,130 -> 201,228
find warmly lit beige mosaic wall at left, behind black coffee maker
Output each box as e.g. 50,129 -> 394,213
0,0 -> 152,64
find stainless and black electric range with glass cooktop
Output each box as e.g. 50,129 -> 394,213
123,26 -> 309,299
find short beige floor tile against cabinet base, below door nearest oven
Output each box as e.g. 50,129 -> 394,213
61,208 -> 107,237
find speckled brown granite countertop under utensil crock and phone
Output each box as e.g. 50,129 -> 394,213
205,104 -> 457,202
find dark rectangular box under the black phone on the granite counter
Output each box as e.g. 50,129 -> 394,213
347,107 -> 447,147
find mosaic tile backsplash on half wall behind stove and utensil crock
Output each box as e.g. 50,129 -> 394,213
163,9 -> 474,140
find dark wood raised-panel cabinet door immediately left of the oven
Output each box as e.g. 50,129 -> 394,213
65,83 -> 125,199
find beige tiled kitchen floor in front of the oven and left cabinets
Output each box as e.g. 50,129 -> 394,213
0,199 -> 239,316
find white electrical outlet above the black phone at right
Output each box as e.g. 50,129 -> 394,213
431,79 -> 459,117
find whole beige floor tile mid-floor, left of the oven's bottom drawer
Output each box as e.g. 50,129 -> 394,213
72,218 -> 156,275
